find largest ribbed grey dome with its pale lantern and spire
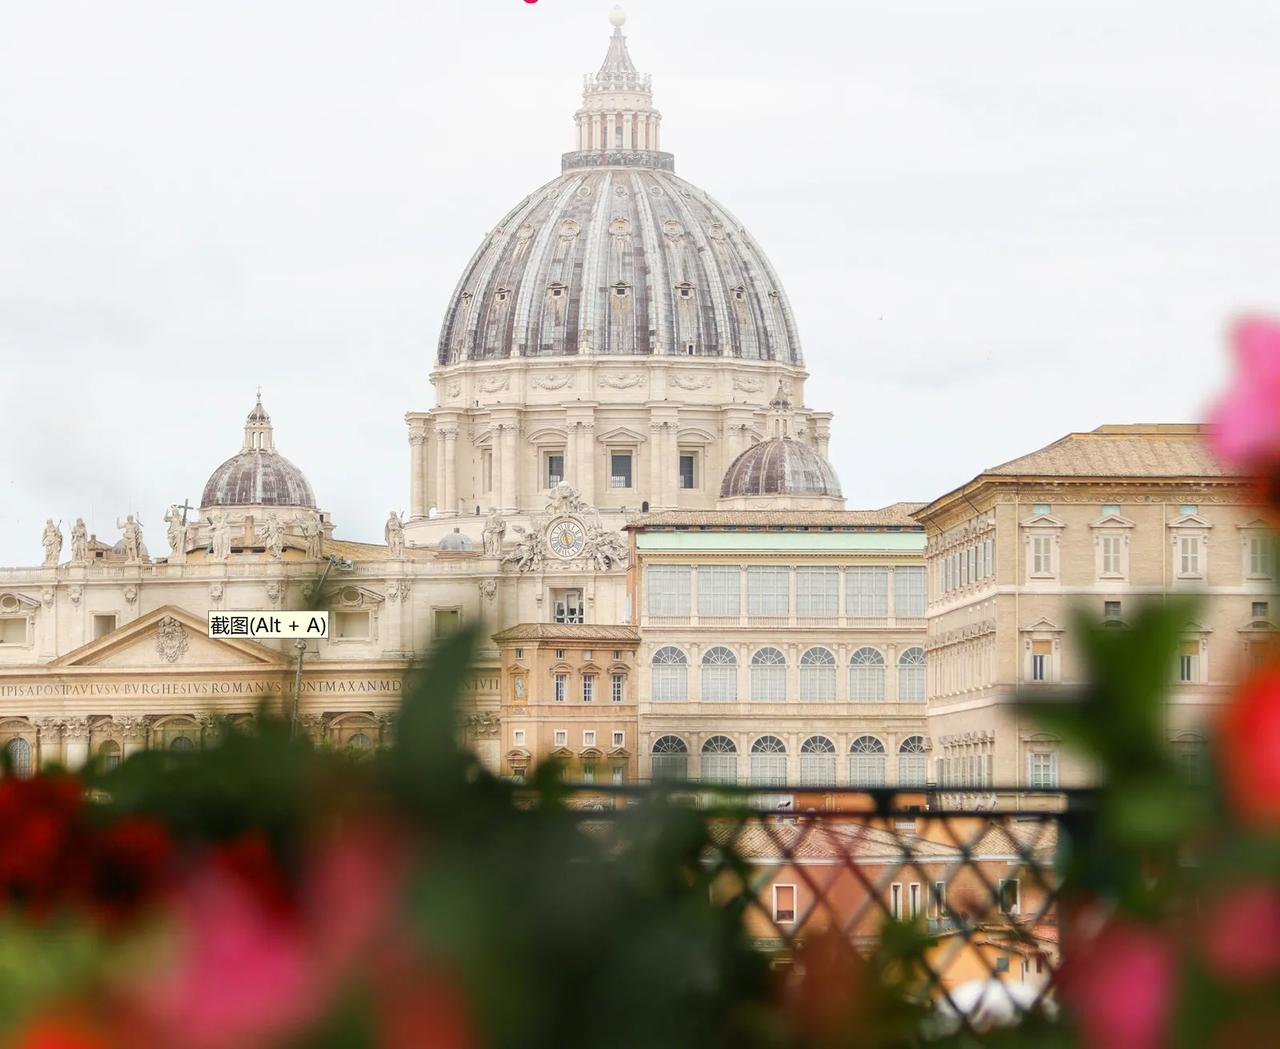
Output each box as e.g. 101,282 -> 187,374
438,17 -> 803,366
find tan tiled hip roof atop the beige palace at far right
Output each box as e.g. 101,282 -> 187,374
983,423 -> 1240,477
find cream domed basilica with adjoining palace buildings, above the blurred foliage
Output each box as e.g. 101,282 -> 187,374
0,9 -> 1276,806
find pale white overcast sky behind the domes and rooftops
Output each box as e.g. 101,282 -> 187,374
0,0 -> 1280,564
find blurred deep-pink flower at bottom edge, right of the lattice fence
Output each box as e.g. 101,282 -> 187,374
1062,919 -> 1176,1049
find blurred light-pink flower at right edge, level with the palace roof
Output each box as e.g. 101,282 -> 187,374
1210,317 -> 1280,467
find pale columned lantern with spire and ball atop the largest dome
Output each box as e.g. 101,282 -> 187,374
561,8 -> 675,171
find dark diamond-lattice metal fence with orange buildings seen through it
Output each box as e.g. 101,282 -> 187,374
571,784 -> 1091,1032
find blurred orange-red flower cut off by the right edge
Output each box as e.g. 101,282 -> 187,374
1219,669 -> 1280,829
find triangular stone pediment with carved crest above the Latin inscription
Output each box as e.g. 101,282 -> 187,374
50,605 -> 288,670
